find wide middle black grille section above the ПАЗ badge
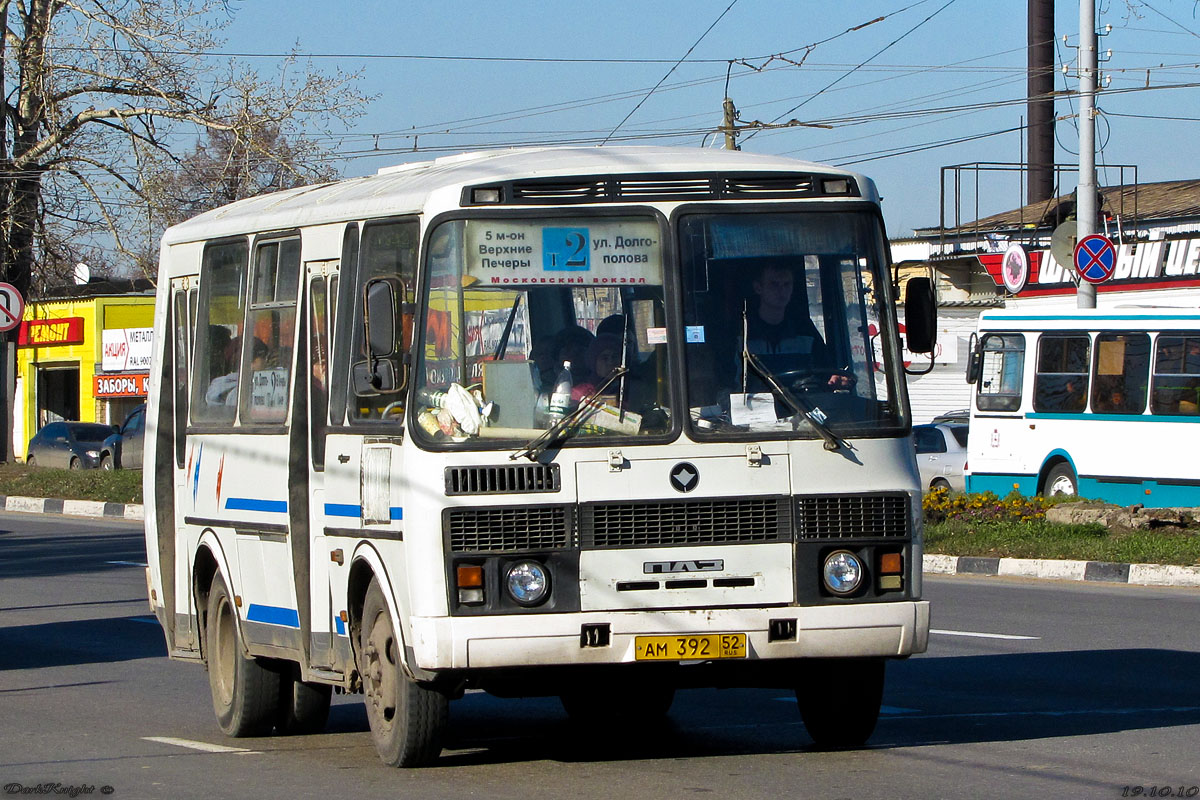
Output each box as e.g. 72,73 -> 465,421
580,497 -> 792,549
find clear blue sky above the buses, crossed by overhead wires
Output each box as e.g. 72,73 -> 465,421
213,0 -> 1200,236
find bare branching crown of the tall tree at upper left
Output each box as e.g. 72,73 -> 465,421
0,0 -> 366,293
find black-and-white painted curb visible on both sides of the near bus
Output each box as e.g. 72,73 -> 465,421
0,497 -> 1200,587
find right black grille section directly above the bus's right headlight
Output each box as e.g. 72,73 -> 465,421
796,494 -> 910,539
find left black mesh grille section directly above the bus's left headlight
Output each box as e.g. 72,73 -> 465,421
443,505 -> 575,553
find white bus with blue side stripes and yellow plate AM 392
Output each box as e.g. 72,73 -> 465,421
145,148 -> 932,765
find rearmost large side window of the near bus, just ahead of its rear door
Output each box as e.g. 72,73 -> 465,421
191,241 -> 250,423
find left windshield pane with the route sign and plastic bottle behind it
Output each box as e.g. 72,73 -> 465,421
415,215 -> 671,445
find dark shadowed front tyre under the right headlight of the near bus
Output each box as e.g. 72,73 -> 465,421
796,658 -> 884,750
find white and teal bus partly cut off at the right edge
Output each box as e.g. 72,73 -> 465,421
966,306 -> 1200,506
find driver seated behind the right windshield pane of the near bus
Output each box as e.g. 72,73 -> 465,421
737,263 -> 853,389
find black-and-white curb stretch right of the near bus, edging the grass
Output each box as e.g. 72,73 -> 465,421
923,554 -> 1200,587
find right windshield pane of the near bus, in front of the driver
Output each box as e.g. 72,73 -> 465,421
679,211 -> 901,438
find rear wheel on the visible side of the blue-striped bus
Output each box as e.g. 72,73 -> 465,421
204,573 -> 280,736
